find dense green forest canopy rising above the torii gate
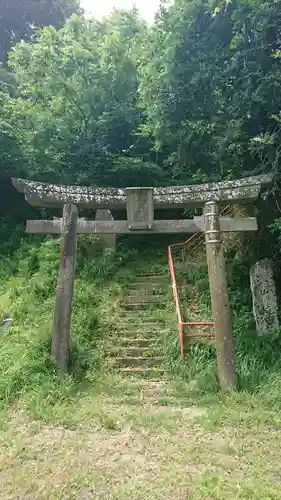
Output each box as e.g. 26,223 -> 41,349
0,0 -> 281,256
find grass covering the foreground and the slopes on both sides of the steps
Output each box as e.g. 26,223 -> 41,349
0,229 -> 281,500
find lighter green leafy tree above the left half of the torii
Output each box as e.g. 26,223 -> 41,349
0,11 -> 161,186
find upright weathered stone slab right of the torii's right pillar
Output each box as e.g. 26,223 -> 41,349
250,259 -> 279,335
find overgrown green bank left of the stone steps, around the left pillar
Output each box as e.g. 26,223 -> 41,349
0,232 -> 118,404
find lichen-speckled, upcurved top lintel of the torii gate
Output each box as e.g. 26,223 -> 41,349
12,174 -> 273,209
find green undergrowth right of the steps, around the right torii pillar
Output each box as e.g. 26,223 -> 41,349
162,255 -> 281,406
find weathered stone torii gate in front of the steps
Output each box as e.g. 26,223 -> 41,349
12,175 -> 272,389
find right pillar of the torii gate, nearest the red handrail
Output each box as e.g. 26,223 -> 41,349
204,201 -> 238,391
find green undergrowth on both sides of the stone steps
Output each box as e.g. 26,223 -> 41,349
0,219 -> 281,418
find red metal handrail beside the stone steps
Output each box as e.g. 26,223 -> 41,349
168,205 -> 238,359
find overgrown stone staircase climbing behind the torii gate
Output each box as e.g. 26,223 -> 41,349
112,274 -> 168,376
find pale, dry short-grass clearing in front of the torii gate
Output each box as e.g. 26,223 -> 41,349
0,380 -> 281,500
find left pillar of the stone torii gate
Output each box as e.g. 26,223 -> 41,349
51,203 -> 78,370
